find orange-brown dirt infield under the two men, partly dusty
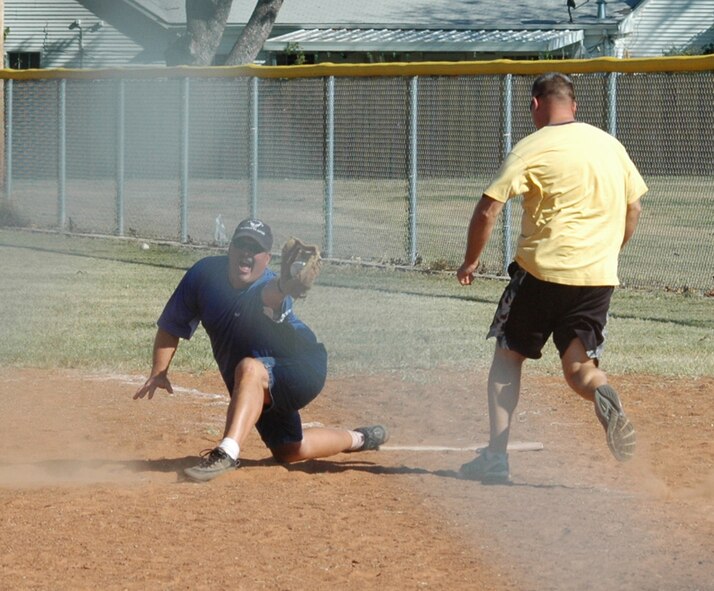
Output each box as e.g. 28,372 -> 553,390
0,368 -> 714,591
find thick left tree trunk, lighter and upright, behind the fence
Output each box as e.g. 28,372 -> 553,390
166,0 -> 233,66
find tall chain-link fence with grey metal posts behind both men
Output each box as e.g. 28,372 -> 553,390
4,58 -> 714,290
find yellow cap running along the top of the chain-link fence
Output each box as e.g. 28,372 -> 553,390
0,55 -> 714,80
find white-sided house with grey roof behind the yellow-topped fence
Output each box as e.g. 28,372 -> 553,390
4,0 -> 714,67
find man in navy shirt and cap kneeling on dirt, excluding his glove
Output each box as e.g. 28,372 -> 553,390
134,219 -> 388,481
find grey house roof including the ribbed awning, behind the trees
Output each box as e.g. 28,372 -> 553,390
128,0 -> 643,57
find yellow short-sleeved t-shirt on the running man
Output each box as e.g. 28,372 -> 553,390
484,122 -> 647,285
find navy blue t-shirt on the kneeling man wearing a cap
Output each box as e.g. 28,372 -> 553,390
157,256 -> 324,391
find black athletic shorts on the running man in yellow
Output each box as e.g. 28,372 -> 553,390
487,262 -> 614,360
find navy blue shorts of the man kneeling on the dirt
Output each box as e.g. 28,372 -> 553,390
255,345 -> 327,449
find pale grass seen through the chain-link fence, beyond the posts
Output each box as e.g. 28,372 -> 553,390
8,175 -> 714,294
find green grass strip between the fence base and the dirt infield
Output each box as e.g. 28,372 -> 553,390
0,229 -> 714,376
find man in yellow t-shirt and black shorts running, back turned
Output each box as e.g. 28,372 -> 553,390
457,73 -> 647,482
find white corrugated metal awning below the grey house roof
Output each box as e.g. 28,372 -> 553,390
263,29 -> 583,54
